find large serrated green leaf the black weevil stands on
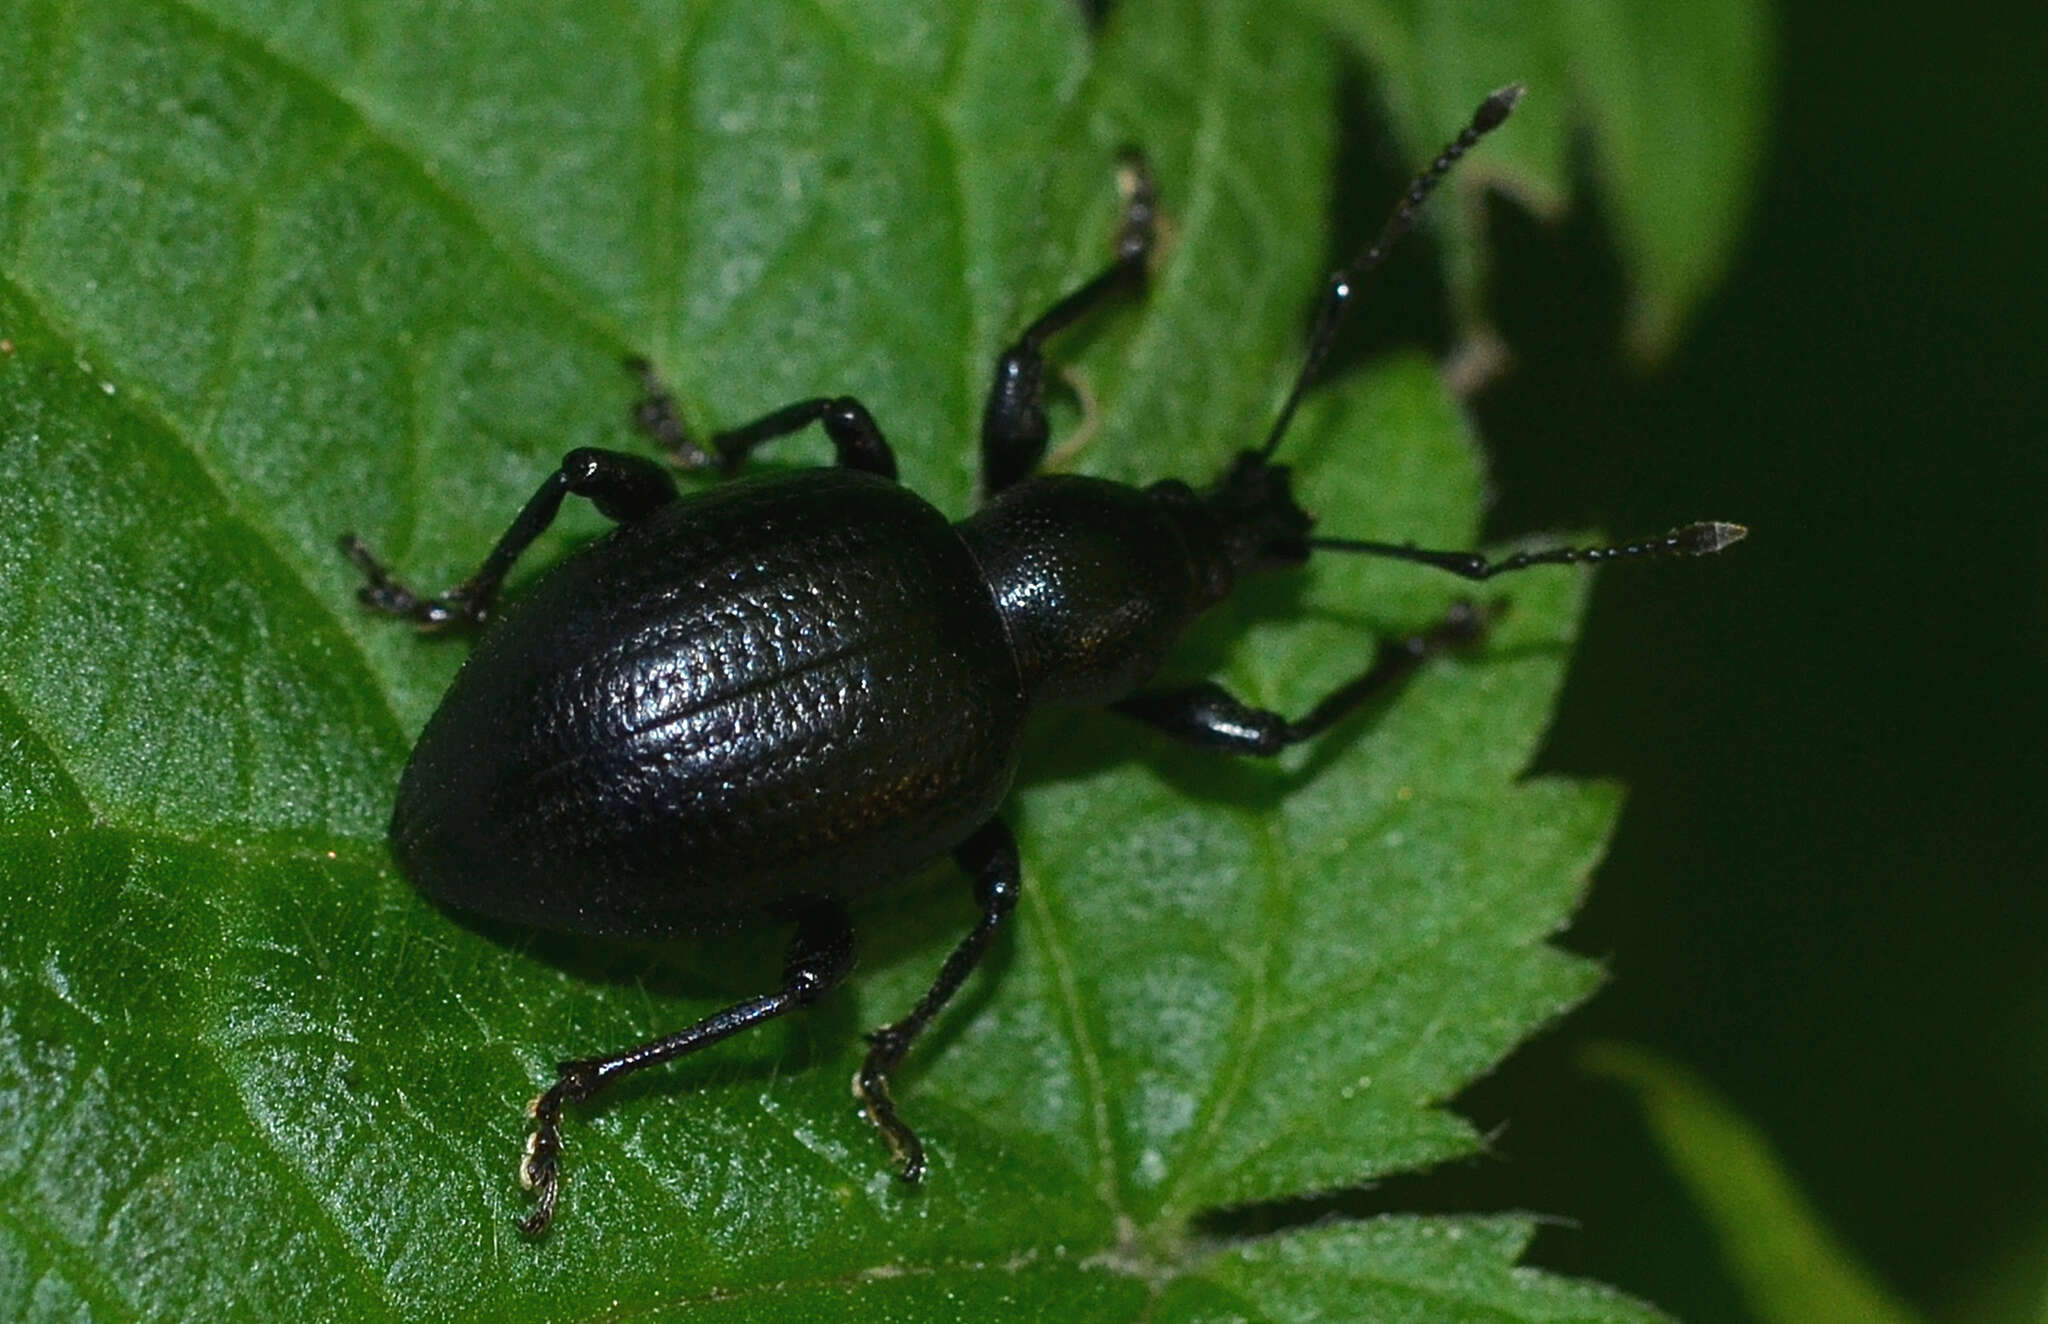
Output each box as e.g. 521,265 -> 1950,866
0,0 -> 1744,1320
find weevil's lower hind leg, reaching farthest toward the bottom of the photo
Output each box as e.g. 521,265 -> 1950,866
518,902 -> 854,1236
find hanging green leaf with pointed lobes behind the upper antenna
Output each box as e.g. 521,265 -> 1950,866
1296,0 -> 1772,355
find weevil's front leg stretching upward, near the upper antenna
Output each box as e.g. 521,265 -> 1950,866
981,150 -> 1159,496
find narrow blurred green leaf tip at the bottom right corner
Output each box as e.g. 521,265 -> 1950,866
1585,1043 -> 1917,1324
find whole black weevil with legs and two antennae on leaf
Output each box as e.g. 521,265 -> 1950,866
342,86 -> 1745,1236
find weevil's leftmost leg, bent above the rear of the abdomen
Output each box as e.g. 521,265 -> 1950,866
342,447 -> 676,629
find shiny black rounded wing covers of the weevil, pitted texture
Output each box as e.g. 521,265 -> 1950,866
391,469 -> 1024,937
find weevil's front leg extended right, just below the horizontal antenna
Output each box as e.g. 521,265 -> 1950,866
1112,603 -> 1487,754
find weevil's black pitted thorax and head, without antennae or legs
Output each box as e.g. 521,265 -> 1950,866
958,453 -> 1311,705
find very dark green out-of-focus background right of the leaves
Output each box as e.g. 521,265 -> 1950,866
1359,4 -> 2048,1320
